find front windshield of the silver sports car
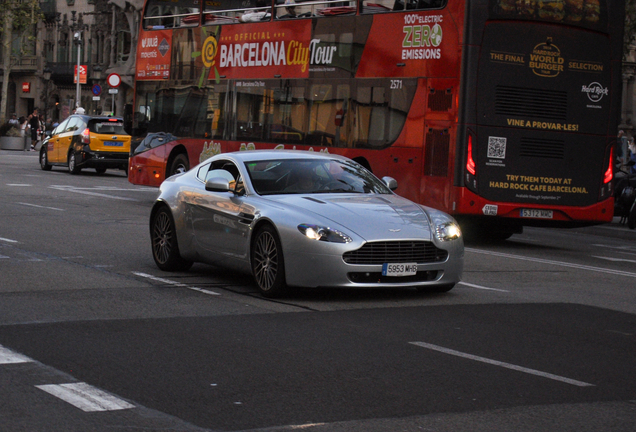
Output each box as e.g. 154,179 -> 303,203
245,159 -> 391,195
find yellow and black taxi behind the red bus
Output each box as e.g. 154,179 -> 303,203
40,114 -> 130,174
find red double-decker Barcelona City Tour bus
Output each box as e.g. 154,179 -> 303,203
129,0 -> 625,238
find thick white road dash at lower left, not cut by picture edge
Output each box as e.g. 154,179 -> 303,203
35,382 -> 135,412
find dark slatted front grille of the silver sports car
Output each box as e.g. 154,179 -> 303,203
342,241 -> 448,265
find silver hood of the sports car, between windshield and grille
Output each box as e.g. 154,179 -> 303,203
268,194 -> 431,241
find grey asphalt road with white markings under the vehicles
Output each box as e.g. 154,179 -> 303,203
0,151 -> 636,432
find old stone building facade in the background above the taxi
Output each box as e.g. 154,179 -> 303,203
0,0 -> 143,122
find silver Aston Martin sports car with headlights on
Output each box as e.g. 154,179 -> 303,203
150,150 -> 464,297
